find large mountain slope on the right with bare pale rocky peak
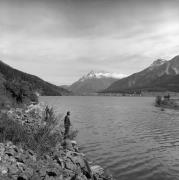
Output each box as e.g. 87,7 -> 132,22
104,56 -> 179,93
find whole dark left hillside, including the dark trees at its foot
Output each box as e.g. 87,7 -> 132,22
0,61 -> 70,107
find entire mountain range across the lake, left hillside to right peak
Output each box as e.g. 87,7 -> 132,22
0,53 -> 179,105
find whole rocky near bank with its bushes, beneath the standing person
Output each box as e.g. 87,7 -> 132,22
0,104 -> 113,180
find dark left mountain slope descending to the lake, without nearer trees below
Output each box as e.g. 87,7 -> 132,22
0,61 -> 69,96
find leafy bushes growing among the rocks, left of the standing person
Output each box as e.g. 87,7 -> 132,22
0,106 -> 63,155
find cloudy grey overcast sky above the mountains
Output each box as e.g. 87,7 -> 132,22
0,0 -> 179,85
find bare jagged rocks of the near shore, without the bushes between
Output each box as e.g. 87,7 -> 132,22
0,103 -> 112,180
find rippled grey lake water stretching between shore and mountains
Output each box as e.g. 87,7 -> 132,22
41,97 -> 179,180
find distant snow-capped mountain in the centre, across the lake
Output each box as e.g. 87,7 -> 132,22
69,71 -> 124,94
